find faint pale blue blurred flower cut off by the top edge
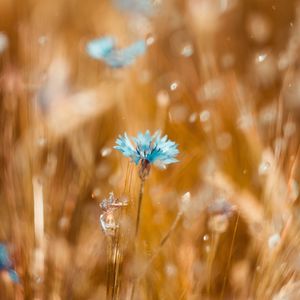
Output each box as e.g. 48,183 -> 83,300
112,0 -> 154,16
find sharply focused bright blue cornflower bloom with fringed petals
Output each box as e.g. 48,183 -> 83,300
114,130 -> 179,168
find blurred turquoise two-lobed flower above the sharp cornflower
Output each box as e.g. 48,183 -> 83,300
86,36 -> 147,68
